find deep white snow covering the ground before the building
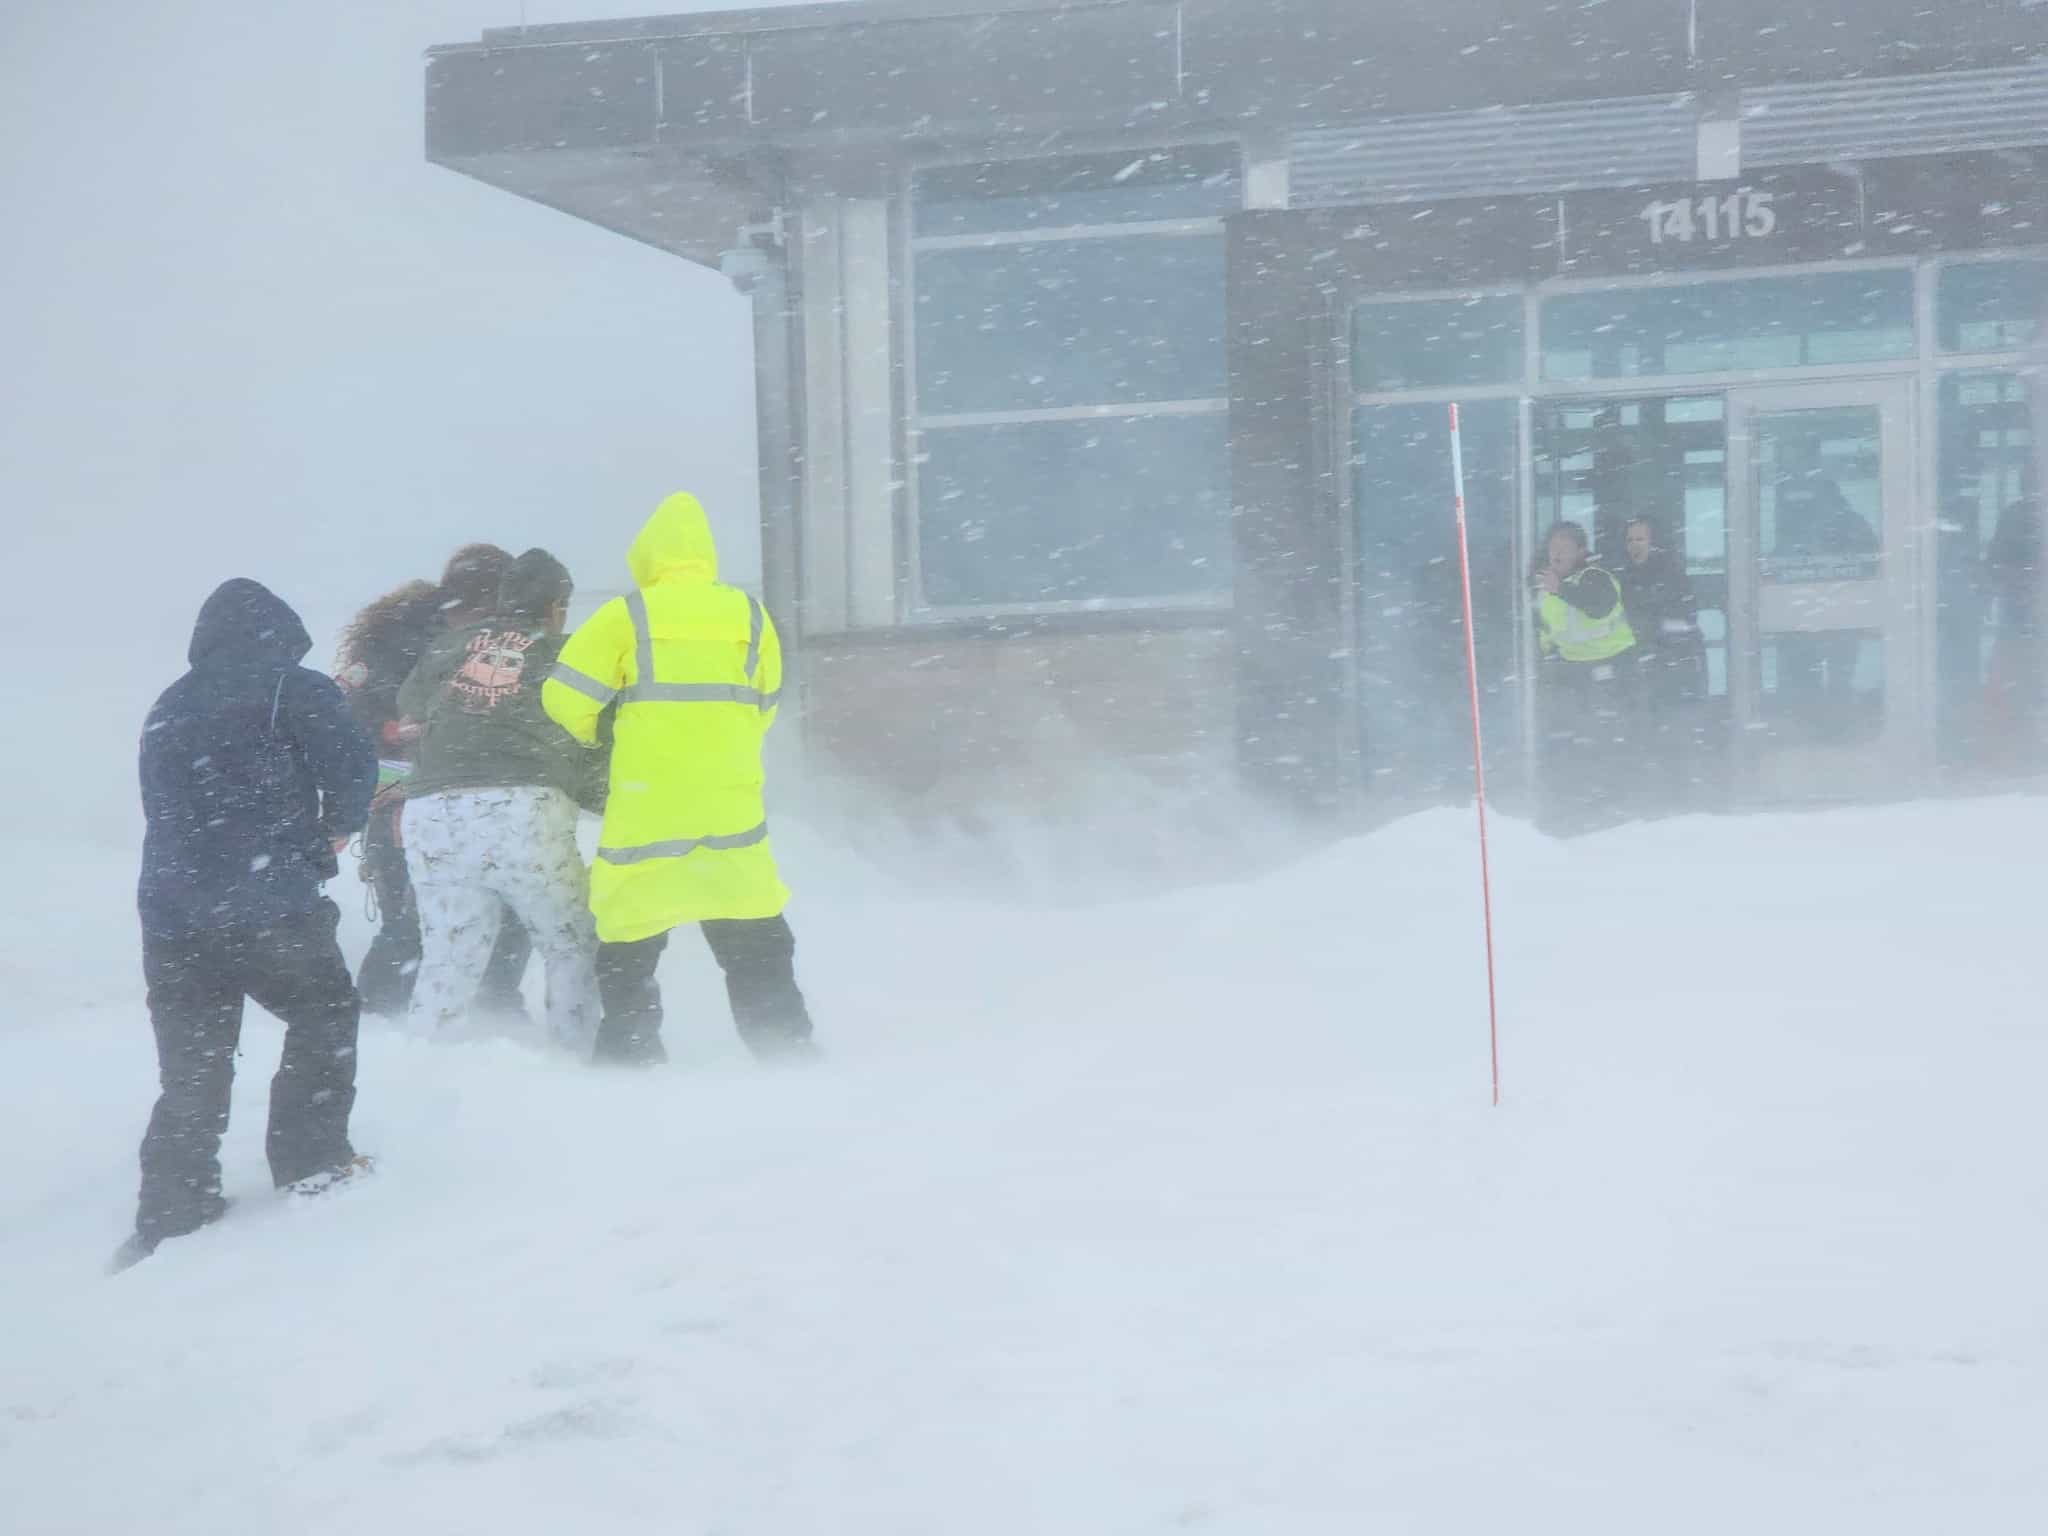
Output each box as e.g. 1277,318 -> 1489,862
0,799 -> 2048,1536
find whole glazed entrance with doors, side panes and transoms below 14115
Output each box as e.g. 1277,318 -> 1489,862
1339,252 -> 2048,811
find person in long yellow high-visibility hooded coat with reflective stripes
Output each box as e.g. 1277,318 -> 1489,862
541,492 -> 813,1063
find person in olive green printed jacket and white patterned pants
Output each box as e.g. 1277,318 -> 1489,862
397,549 -> 602,1051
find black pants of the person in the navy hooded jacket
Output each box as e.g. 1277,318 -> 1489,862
135,901 -> 356,1243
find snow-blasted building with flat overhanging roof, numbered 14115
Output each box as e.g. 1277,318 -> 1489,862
428,0 -> 2048,807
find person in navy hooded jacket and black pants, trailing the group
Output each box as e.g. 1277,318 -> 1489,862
117,580 -> 377,1264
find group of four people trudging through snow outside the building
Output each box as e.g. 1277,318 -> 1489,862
115,494 -> 813,1268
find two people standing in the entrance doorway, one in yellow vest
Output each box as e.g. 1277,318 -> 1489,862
1536,518 -> 1708,834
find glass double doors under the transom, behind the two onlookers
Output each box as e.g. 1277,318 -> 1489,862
1528,379 -> 1931,805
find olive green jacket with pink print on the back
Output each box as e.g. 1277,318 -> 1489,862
397,618 -> 604,811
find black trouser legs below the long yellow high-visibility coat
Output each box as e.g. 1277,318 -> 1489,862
594,918 -> 811,1063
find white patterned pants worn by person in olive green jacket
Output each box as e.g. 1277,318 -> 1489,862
403,786 -> 598,1051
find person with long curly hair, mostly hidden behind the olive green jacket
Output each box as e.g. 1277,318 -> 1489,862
336,543 -> 532,1018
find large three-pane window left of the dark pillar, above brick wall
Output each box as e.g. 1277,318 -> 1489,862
911,147 -> 1239,608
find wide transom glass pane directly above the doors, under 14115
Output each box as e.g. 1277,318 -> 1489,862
1542,272 -> 1913,379
